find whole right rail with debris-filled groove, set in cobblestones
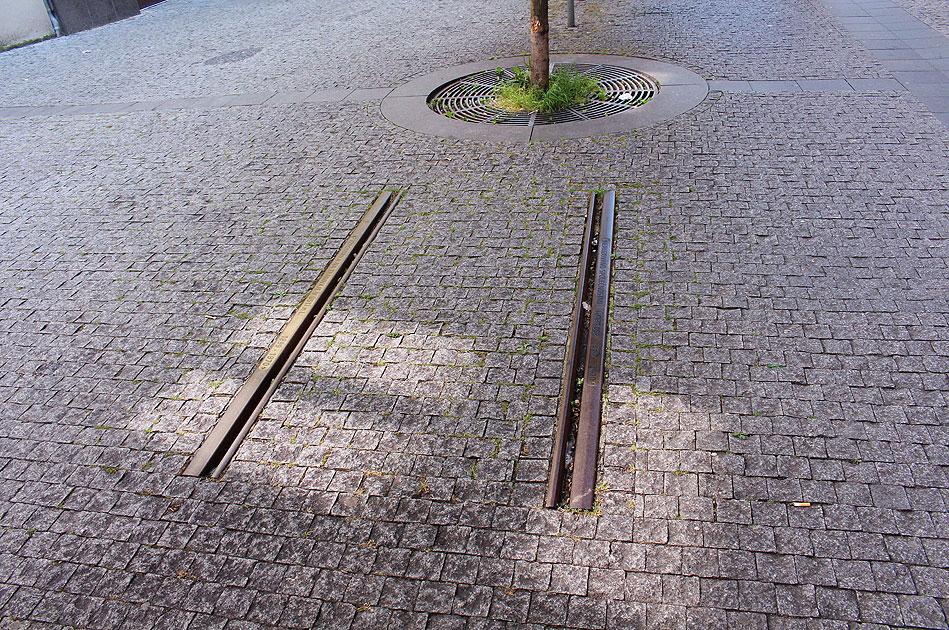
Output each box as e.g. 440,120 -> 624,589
545,190 -> 616,510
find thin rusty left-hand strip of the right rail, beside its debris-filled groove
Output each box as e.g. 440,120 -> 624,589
544,192 -> 596,508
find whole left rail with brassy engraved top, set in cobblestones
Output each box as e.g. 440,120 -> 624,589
181,191 -> 398,477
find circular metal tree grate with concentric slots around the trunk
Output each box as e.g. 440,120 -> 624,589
428,63 -> 659,127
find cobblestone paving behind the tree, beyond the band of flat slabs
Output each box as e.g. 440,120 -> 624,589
0,0 -> 887,106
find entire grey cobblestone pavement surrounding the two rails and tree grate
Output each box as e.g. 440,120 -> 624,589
0,0 -> 949,630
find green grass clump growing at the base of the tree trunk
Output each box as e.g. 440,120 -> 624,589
494,68 -> 604,114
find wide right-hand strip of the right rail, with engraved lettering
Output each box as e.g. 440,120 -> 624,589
570,190 -> 616,510
